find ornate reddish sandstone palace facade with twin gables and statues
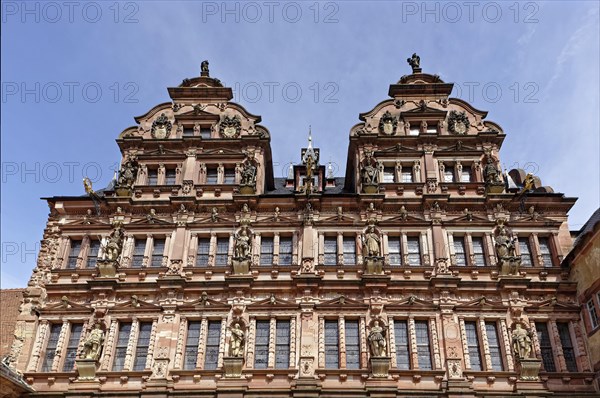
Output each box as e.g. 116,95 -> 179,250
6,54 -> 594,397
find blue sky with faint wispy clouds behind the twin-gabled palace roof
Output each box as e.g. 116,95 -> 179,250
0,1 -> 600,288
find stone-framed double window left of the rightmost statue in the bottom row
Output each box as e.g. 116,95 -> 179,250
459,315 -> 514,372
